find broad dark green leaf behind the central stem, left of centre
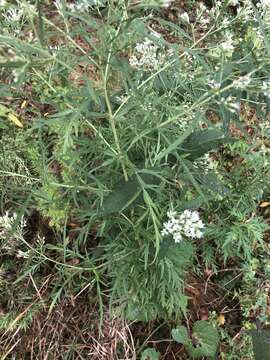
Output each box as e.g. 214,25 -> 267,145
101,173 -> 161,215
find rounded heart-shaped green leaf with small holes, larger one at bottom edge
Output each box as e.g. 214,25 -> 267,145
187,320 -> 219,359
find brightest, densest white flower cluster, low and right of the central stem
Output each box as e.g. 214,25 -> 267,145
161,210 -> 204,243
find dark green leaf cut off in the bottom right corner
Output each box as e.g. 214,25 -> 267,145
248,330 -> 270,360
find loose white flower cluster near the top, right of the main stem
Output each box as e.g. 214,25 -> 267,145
129,38 -> 165,70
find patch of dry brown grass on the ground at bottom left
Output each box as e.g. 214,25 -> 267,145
1,296 -> 136,360
